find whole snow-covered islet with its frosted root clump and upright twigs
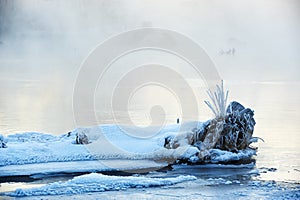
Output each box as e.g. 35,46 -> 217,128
0,83 -> 259,196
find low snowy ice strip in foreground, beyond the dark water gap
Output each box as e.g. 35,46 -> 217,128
5,173 -> 197,197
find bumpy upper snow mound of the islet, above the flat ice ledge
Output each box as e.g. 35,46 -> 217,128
0,122 -> 202,166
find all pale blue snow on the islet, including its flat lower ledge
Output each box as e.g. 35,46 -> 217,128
0,122 -> 255,177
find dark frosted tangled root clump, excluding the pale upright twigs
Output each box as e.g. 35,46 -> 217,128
191,101 -> 255,152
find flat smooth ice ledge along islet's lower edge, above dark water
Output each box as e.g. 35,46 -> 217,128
0,160 -> 167,178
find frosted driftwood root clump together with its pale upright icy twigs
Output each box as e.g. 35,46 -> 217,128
164,82 -> 260,162
